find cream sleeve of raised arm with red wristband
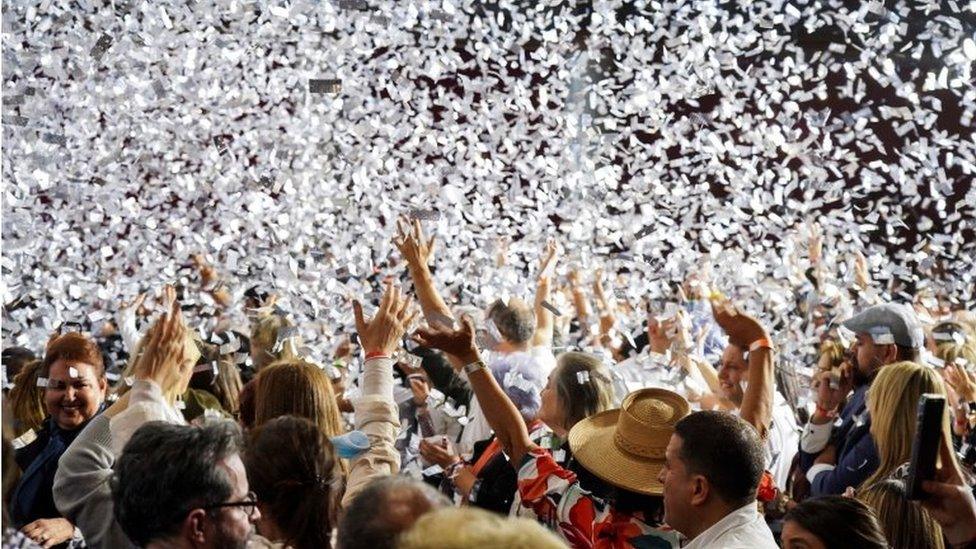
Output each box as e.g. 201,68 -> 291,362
342,357 -> 400,506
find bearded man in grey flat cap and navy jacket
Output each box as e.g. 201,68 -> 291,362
800,303 -> 925,496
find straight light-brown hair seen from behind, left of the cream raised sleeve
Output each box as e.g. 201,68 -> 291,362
254,359 -> 344,437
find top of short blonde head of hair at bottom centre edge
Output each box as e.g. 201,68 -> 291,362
397,507 -> 566,549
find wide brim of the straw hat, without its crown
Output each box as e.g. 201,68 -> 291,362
569,409 -> 664,496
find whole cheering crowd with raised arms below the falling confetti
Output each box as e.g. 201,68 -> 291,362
3,219 -> 976,549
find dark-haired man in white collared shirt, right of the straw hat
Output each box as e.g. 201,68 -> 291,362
658,411 -> 777,549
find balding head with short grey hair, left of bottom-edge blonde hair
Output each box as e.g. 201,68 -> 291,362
336,477 -> 450,549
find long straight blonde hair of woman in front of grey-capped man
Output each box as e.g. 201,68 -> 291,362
863,362 -> 955,486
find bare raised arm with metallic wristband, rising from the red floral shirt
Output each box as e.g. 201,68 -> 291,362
413,318 -> 535,467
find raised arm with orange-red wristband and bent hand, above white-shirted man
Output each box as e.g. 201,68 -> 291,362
712,299 -> 775,439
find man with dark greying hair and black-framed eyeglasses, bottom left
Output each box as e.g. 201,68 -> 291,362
112,420 -> 261,549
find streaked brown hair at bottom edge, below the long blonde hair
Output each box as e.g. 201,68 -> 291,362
857,480 -> 945,549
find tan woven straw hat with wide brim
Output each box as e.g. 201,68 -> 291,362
569,389 -> 690,495
